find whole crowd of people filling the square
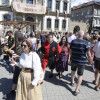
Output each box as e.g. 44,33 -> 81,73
0,30 -> 100,100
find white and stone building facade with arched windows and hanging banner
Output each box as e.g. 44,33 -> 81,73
0,0 -> 71,32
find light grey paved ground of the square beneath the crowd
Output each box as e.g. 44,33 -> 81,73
0,61 -> 100,100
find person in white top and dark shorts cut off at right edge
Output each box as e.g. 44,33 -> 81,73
93,38 -> 100,91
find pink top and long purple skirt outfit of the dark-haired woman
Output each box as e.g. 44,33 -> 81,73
56,45 -> 69,72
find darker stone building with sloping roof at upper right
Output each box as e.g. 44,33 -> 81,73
70,1 -> 100,33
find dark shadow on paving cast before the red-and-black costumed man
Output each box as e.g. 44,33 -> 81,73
44,71 -> 73,93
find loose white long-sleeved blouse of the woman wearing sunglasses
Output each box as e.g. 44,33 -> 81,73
16,52 -> 41,86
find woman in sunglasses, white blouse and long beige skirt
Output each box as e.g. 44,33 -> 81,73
10,40 -> 42,100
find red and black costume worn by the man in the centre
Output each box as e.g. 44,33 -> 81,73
41,41 -> 61,70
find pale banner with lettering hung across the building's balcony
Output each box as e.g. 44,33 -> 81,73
12,1 -> 46,15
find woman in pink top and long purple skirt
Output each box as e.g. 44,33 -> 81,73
56,36 -> 69,78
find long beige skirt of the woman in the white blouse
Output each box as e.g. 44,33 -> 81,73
16,71 -> 43,100
